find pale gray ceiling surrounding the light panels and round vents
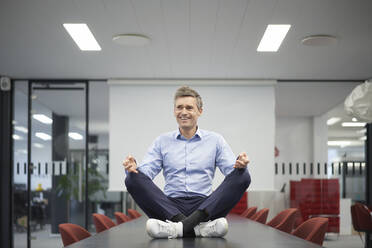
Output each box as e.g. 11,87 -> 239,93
0,0 -> 372,80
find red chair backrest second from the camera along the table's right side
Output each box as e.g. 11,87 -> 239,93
266,208 -> 299,233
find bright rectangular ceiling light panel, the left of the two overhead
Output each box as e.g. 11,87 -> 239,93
63,23 -> 101,51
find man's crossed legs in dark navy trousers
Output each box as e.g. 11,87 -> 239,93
125,169 -> 251,236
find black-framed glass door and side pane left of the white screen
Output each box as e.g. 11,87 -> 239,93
13,81 -> 89,247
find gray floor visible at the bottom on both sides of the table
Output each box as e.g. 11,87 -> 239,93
14,226 -> 364,248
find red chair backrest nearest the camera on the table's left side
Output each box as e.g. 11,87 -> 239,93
58,223 -> 91,246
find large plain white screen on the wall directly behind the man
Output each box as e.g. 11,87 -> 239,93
109,80 -> 275,191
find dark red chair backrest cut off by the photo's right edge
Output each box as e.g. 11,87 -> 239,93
351,203 -> 372,232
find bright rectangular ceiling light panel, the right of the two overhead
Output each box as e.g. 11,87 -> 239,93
257,24 -> 291,52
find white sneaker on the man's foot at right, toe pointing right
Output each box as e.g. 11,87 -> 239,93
194,217 -> 229,238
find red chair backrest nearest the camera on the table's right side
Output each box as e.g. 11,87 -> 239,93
292,217 -> 328,245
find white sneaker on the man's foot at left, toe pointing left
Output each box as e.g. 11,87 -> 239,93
146,219 -> 183,239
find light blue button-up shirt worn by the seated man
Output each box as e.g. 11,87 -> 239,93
138,128 -> 236,197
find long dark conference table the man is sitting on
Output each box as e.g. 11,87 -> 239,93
67,215 -> 321,248
